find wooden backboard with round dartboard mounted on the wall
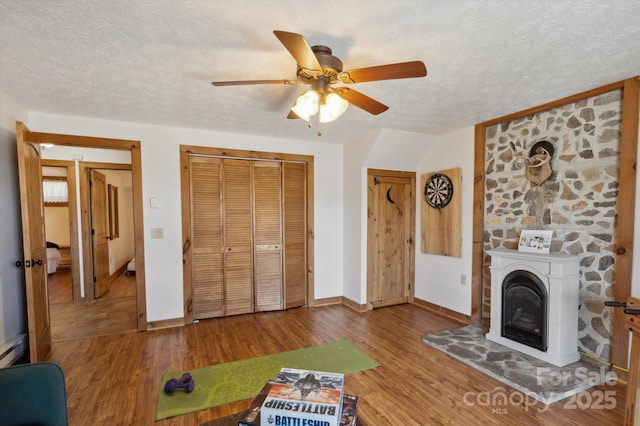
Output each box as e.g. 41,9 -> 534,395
420,167 -> 462,257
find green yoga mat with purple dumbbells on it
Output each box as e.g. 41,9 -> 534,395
156,340 -> 380,420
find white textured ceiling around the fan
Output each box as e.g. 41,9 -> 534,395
0,0 -> 640,143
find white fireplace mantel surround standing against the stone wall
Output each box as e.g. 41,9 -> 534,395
486,249 -> 581,367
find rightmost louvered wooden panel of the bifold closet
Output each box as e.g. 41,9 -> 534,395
282,163 -> 307,308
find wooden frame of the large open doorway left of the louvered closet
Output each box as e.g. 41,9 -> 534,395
16,121 -> 148,331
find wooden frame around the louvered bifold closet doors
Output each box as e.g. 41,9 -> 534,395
180,145 -> 316,325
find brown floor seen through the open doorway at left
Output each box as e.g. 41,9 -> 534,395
47,270 -> 138,342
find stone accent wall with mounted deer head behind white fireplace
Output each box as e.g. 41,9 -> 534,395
483,90 -> 622,360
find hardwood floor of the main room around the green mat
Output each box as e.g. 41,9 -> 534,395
49,304 -> 626,426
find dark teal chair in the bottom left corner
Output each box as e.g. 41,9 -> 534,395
0,362 -> 69,426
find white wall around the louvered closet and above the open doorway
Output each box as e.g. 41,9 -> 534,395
29,112 -> 343,321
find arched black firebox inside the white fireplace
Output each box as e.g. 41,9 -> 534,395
502,270 -> 547,352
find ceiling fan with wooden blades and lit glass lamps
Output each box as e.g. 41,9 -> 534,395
212,31 -> 427,123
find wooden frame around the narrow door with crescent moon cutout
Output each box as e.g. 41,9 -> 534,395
366,169 -> 416,310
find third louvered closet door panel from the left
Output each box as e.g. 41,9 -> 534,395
253,161 -> 283,312
